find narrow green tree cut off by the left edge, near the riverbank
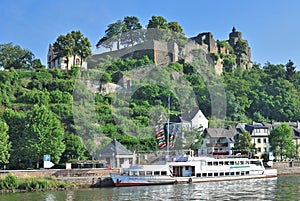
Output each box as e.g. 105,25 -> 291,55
0,119 -> 11,165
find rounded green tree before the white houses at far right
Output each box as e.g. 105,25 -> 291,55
269,123 -> 296,161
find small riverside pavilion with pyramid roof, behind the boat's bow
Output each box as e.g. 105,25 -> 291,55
95,139 -> 135,168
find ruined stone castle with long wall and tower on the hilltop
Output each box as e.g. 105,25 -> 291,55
88,27 -> 252,74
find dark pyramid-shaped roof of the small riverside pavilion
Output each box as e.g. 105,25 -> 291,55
96,140 -> 133,157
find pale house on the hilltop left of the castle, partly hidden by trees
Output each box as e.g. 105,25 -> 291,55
47,44 -> 87,70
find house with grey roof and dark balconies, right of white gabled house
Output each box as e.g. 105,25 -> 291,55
199,128 -> 238,155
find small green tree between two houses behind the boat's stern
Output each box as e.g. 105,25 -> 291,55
233,131 -> 253,156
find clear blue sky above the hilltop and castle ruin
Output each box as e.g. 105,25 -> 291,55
0,0 -> 300,70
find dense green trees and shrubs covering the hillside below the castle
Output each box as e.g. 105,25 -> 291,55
0,18 -> 300,169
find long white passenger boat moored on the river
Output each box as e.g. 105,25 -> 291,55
111,156 -> 277,187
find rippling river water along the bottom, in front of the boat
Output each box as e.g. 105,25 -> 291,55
0,175 -> 300,201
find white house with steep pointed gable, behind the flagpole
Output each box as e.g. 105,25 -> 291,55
181,108 -> 208,131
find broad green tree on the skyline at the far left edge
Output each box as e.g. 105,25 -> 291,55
0,43 -> 34,69
